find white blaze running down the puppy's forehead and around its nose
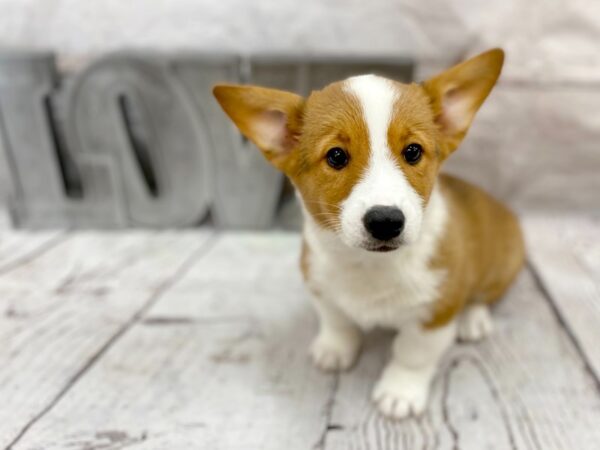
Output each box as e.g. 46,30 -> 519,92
341,75 -> 423,245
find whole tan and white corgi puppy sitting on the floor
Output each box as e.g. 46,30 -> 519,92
213,49 -> 524,419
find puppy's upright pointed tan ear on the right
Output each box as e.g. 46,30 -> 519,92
423,48 -> 504,154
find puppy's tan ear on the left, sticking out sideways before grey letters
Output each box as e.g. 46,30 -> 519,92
213,85 -> 304,170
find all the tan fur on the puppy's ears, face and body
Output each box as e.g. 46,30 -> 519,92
214,49 -> 524,327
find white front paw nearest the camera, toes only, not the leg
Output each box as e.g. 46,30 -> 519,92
372,367 -> 431,419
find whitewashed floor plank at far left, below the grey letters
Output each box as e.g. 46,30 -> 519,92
0,232 -> 216,448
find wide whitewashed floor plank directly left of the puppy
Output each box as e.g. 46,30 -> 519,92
9,234 -> 333,450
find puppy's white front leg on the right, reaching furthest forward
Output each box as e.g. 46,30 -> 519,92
373,321 -> 456,419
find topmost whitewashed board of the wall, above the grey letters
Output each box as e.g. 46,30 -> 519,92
0,0 -> 600,82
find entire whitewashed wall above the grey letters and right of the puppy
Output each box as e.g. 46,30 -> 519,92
0,0 -> 600,210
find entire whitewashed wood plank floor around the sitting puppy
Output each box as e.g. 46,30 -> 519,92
0,217 -> 600,450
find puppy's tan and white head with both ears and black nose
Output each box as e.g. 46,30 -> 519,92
214,49 -> 504,251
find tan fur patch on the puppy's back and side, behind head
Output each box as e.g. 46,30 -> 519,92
427,175 -> 524,327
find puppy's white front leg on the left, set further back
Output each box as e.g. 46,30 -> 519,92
310,297 -> 362,371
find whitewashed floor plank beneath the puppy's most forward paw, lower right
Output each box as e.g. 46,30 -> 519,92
324,272 -> 600,450
